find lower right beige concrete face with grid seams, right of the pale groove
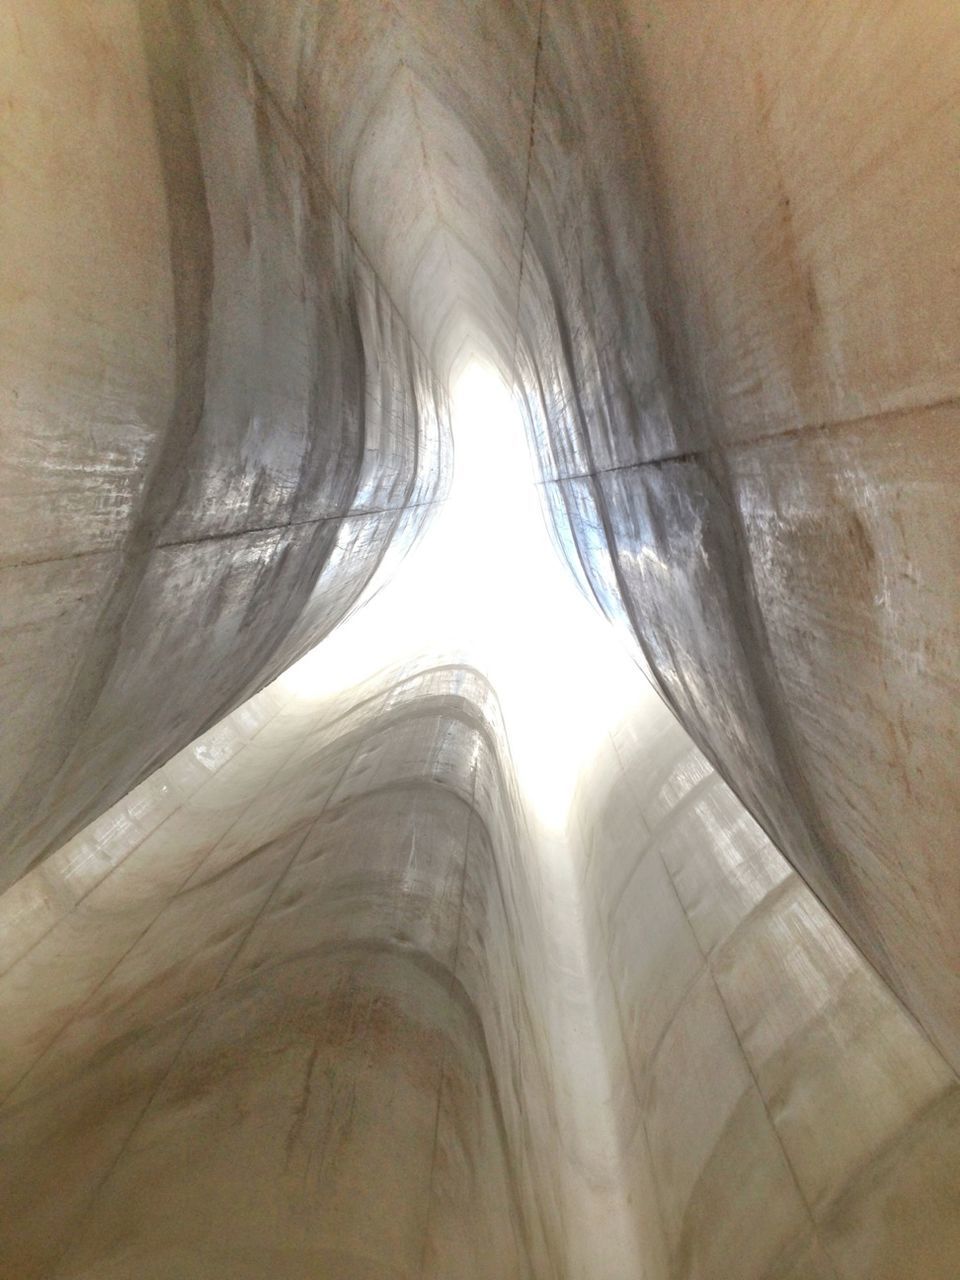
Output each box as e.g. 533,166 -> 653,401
571,690 -> 960,1280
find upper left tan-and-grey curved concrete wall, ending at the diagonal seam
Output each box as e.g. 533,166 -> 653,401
0,0 -> 445,883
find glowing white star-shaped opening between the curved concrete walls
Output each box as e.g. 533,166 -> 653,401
283,364 -> 636,831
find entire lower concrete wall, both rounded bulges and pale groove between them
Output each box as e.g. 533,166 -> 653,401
0,662 -> 960,1280
